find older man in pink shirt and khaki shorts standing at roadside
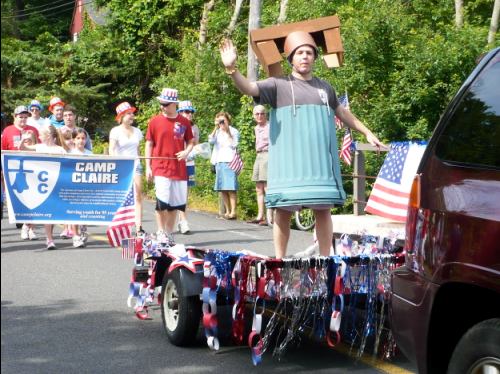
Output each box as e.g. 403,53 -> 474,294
248,105 -> 269,226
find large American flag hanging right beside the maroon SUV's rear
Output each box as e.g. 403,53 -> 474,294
365,142 -> 427,222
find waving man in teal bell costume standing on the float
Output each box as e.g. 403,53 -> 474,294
220,31 -> 384,258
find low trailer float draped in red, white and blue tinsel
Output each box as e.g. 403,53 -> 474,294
122,236 -> 403,365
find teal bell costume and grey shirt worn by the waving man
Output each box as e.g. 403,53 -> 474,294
254,76 -> 346,209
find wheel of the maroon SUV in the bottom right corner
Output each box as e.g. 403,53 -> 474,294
448,318 -> 500,374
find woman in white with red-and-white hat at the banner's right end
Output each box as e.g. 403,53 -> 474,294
109,101 -> 145,235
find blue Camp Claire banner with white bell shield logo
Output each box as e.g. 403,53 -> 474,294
2,151 -> 135,226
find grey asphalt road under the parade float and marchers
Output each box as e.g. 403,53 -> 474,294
1,202 -> 414,374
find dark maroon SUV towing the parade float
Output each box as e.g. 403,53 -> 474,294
390,48 -> 500,374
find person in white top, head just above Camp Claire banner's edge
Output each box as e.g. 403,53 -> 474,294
19,125 -> 66,250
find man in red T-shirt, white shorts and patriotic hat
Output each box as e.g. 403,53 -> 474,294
145,88 -> 194,245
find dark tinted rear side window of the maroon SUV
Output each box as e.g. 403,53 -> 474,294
436,53 -> 500,168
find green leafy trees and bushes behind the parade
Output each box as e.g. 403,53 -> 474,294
1,0 -> 500,216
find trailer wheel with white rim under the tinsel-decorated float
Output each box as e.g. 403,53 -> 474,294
161,269 -> 201,346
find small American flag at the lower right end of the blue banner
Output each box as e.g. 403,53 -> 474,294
106,186 -> 135,247
